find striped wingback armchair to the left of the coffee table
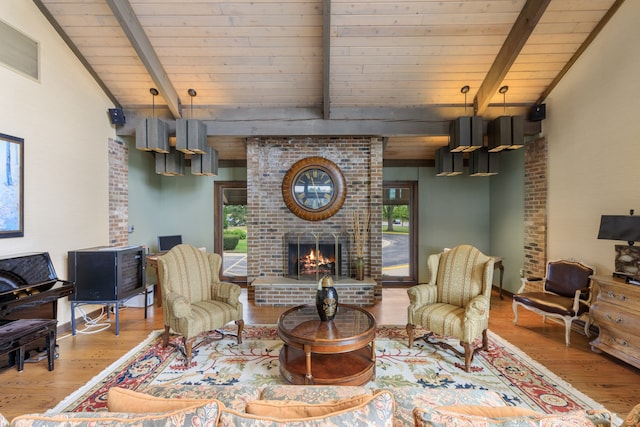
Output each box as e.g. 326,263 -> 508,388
158,244 -> 244,366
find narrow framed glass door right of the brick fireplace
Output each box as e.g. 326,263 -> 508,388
382,181 -> 418,285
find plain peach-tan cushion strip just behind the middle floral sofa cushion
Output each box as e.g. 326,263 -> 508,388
245,395 -> 371,420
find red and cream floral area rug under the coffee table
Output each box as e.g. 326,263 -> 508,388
49,325 -> 602,420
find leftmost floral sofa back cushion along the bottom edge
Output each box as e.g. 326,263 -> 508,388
11,401 -> 220,427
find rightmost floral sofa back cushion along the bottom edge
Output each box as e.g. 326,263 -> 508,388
413,408 -> 611,427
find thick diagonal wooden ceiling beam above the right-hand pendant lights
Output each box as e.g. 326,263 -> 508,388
473,0 -> 551,115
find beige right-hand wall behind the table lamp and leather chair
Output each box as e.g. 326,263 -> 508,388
543,1 -> 640,275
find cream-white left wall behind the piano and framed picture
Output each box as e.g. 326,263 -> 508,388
0,0 -> 115,323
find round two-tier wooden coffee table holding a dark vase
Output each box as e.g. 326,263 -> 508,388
278,305 -> 376,385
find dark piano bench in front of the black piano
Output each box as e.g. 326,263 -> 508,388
0,319 -> 58,371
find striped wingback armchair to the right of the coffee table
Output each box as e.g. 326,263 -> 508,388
407,245 -> 494,372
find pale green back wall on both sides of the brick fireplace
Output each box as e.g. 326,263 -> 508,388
128,144 -> 524,290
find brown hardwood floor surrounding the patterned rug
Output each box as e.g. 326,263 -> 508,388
0,288 -> 640,420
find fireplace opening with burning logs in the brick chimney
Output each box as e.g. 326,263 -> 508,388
285,233 -> 349,280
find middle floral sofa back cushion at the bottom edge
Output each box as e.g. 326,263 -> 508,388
218,391 -> 394,427
